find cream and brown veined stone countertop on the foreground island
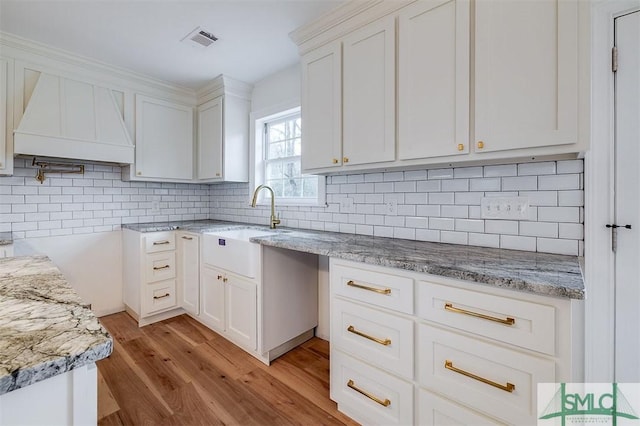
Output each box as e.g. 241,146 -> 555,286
0,256 -> 113,395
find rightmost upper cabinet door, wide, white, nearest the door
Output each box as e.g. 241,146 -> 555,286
475,0 -> 578,152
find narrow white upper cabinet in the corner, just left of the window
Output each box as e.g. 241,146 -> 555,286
196,76 -> 253,183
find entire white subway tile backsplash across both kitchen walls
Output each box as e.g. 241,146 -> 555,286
0,159 -> 584,253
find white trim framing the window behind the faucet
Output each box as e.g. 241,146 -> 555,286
249,100 -> 327,207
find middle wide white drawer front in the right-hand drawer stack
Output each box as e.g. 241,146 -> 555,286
418,324 -> 555,424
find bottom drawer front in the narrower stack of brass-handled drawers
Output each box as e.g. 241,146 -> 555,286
331,350 -> 413,425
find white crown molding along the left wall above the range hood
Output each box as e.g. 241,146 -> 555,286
0,31 -> 195,98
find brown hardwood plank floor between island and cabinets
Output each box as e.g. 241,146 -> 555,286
97,312 -> 356,426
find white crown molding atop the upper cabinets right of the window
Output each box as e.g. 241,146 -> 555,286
289,0 -> 416,55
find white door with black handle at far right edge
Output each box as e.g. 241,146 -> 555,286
612,11 -> 640,382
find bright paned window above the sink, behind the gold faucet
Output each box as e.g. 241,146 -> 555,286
255,108 -> 324,205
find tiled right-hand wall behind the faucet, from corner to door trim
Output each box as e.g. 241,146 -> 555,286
211,160 -> 584,255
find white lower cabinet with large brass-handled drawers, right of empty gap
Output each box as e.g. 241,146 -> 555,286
330,259 -> 583,425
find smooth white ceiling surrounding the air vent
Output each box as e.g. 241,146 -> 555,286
0,0 -> 345,89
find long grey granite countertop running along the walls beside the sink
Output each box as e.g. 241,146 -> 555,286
123,221 -> 584,299
